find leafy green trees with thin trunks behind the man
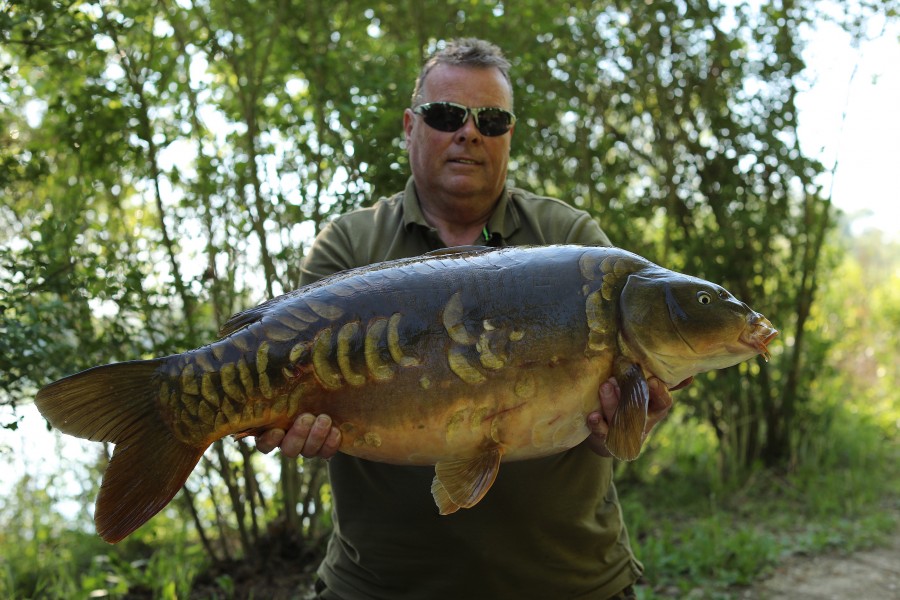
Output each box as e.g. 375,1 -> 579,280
0,0 -> 900,596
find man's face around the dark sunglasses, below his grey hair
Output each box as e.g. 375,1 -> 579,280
403,65 -> 512,204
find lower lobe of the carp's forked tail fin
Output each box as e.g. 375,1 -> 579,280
94,427 -> 206,544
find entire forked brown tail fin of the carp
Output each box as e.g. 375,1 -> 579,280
35,358 -> 206,544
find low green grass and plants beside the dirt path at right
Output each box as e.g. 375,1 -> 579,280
617,406 -> 900,600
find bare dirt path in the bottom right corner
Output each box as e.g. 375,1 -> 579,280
742,532 -> 900,600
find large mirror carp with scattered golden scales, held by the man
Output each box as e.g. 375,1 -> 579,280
35,246 -> 778,543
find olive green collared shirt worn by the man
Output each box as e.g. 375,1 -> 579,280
302,179 -> 643,600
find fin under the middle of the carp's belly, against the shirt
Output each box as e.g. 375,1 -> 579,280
431,446 -> 503,515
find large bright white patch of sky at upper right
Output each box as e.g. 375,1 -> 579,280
797,9 -> 900,240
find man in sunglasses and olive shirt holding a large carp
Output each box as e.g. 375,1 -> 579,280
257,39 -> 669,600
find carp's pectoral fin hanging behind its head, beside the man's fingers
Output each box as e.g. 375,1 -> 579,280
606,360 -> 650,460
